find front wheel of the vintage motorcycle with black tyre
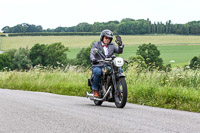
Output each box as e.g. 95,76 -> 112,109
114,77 -> 127,108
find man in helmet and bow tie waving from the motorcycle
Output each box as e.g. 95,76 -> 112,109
90,29 -> 124,98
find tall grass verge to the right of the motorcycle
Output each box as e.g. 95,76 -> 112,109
126,64 -> 200,112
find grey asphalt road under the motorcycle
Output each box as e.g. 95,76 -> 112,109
0,89 -> 200,133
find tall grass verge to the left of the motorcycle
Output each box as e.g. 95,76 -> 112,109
0,68 -> 89,96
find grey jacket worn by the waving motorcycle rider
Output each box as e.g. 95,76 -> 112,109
90,41 -> 124,66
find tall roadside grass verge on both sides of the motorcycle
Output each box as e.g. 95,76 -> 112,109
0,65 -> 200,112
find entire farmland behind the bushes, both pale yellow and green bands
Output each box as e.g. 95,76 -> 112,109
0,35 -> 200,66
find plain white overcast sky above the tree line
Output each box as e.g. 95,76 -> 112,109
0,0 -> 200,30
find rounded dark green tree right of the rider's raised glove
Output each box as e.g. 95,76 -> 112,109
136,43 -> 163,70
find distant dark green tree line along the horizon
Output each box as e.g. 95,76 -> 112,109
2,18 -> 200,35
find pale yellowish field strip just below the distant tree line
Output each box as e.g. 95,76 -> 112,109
2,35 -> 200,50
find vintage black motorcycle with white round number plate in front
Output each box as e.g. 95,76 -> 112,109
87,49 -> 128,108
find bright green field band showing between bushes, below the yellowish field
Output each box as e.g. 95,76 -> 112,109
68,45 -> 200,67
